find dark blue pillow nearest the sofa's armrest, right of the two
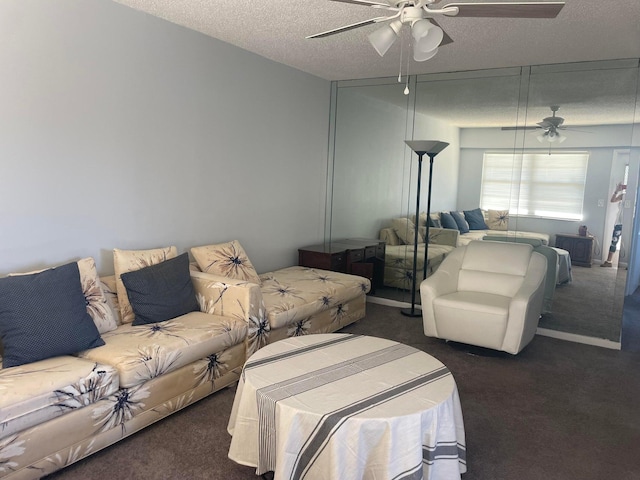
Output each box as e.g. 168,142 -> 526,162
120,252 -> 200,325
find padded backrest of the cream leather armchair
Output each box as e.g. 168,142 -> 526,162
458,241 -> 533,297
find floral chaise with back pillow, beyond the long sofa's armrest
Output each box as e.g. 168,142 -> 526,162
191,240 -> 371,348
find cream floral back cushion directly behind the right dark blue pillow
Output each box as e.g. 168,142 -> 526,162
113,246 -> 178,323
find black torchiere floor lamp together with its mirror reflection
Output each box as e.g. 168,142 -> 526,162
400,140 -> 449,317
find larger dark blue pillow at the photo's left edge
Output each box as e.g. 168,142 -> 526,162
0,262 -> 104,368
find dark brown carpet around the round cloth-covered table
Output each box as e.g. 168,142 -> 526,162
49,303 -> 640,480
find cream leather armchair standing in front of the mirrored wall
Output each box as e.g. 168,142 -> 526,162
420,241 -> 547,355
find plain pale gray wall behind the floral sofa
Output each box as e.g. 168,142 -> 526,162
0,0 -> 330,274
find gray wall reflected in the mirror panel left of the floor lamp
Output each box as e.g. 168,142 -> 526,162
330,86 -> 411,239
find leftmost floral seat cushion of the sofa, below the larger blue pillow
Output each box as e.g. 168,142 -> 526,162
0,355 -> 119,437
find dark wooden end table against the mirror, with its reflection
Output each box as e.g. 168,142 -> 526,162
298,238 -> 385,293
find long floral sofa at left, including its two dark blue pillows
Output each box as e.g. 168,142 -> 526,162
0,247 -> 251,480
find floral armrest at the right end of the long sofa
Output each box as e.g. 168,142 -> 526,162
191,271 -> 271,356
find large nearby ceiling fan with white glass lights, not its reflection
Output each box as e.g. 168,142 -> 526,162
306,0 -> 565,62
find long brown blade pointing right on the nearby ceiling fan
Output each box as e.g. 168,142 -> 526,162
443,2 -> 564,18
